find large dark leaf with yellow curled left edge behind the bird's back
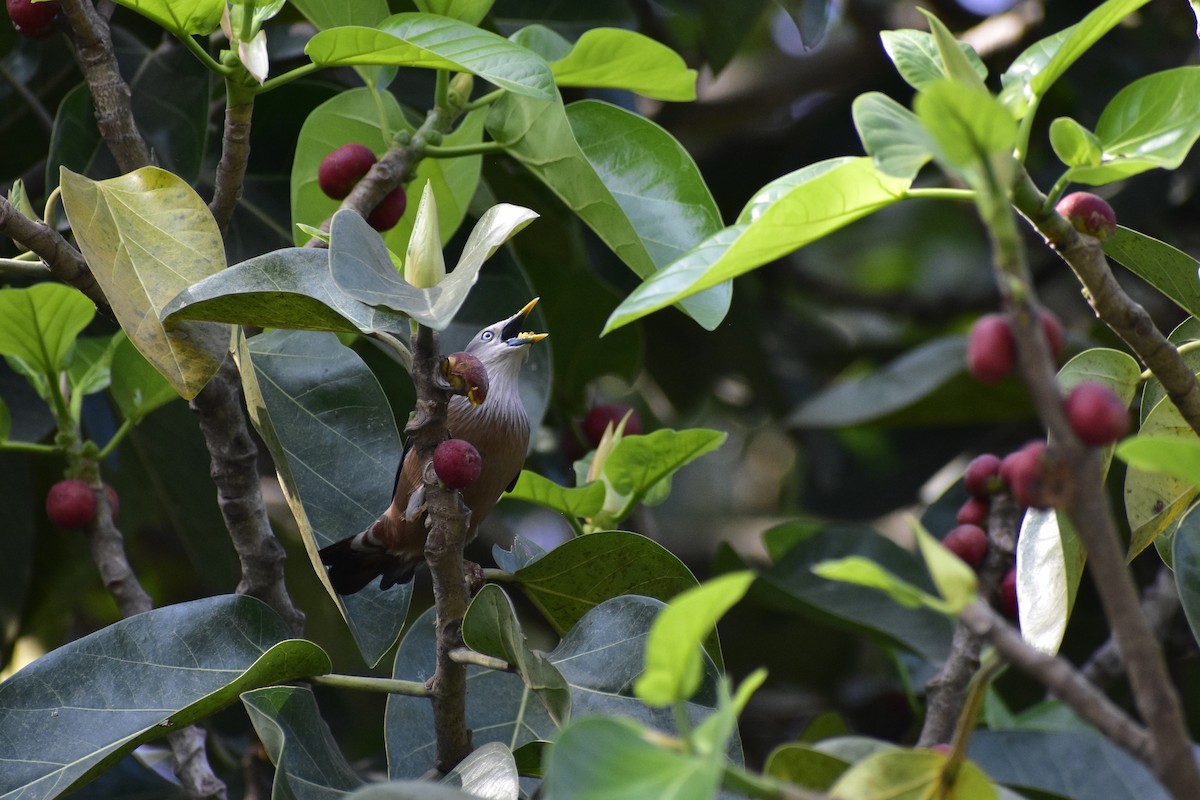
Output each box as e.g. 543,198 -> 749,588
239,331 -> 412,664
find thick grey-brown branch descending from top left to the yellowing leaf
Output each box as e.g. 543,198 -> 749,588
62,0 -> 150,173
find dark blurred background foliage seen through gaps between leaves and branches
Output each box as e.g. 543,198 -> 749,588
0,0 -> 1200,777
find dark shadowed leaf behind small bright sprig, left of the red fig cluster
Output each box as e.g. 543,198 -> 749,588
750,523 -> 953,663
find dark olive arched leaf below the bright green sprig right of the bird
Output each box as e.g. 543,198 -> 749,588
514,530 -> 696,633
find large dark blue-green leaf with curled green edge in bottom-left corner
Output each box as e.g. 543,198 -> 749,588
0,595 -> 330,798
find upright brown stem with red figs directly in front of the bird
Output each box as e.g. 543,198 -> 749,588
404,325 -> 472,774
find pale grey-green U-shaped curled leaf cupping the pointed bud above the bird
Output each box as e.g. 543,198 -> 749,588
329,203 -> 538,331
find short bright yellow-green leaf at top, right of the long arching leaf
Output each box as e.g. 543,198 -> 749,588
550,28 -> 696,102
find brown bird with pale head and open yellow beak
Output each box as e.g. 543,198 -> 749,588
319,297 -> 548,595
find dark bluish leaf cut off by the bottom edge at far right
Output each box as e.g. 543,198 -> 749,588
967,729 -> 1169,800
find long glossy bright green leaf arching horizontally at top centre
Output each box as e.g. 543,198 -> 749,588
305,12 -> 557,100
